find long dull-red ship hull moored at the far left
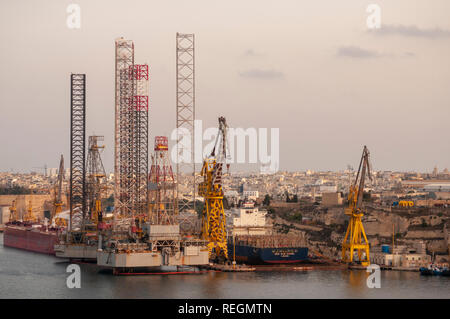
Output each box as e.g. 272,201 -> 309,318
3,224 -> 58,255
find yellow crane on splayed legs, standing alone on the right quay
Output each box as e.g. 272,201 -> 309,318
342,145 -> 372,267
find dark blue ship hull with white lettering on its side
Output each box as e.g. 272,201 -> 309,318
228,243 -> 308,265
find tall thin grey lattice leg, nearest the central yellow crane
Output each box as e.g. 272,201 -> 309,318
176,33 -> 196,219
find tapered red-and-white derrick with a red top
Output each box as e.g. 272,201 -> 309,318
149,136 -> 177,225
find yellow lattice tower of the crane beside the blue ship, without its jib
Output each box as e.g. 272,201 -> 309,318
198,159 -> 228,259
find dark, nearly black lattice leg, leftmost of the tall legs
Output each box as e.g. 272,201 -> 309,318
69,74 -> 86,231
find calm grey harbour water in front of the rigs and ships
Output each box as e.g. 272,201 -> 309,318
0,234 -> 450,299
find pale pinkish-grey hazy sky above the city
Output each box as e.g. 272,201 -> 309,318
0,0 -> 450,172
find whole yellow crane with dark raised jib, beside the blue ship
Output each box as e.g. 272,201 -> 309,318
198,117 -> 229,260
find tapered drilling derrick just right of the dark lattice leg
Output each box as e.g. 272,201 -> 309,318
87,135 -> 106,224
